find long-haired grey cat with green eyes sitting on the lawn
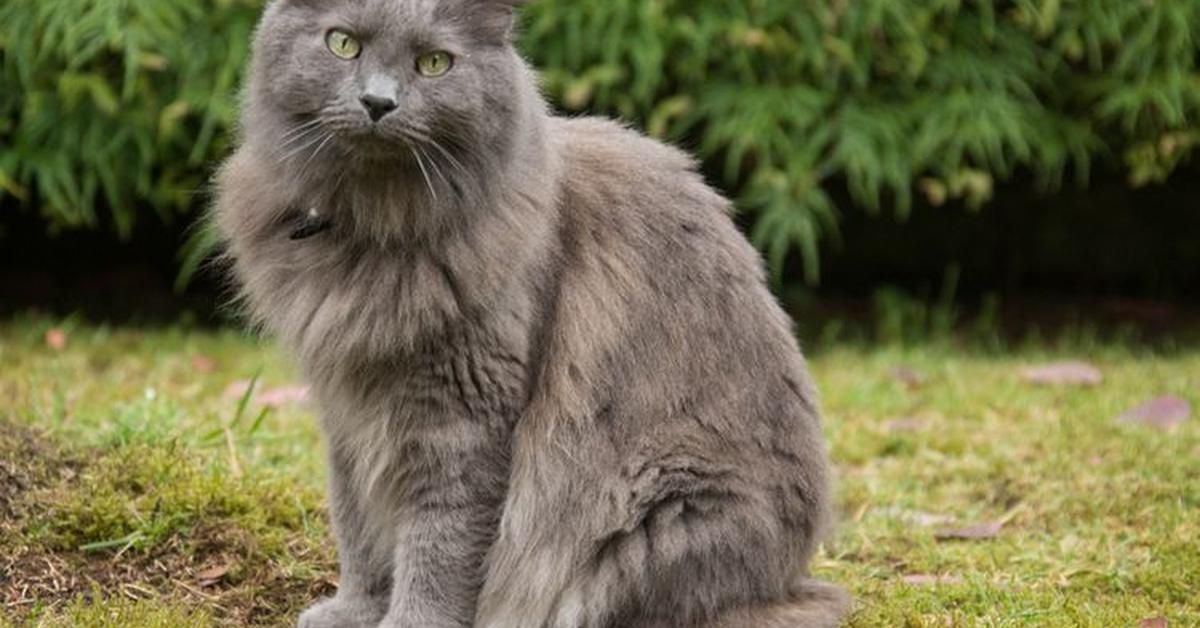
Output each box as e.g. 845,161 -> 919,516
215,0 -> 846,628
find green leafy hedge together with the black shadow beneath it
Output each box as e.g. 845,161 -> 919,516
0,0 -> 1200,317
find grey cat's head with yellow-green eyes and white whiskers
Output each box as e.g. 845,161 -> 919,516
245,0 -> 532,168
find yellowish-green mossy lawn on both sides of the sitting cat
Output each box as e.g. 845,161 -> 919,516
0,318 -> 1200,627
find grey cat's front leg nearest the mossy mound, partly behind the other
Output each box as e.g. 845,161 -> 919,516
300,443 -> 391,628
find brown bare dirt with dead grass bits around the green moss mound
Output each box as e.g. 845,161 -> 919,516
0,423 -> 336,626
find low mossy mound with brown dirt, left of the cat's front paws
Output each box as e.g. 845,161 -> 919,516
0,429 -> 334,627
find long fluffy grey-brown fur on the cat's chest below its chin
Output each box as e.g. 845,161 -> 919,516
213,136 -> 554,506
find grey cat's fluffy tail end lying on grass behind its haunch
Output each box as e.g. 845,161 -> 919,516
704,580 -> 850,628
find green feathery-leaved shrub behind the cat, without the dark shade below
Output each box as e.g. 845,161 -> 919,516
0,0 -> 1200,280
